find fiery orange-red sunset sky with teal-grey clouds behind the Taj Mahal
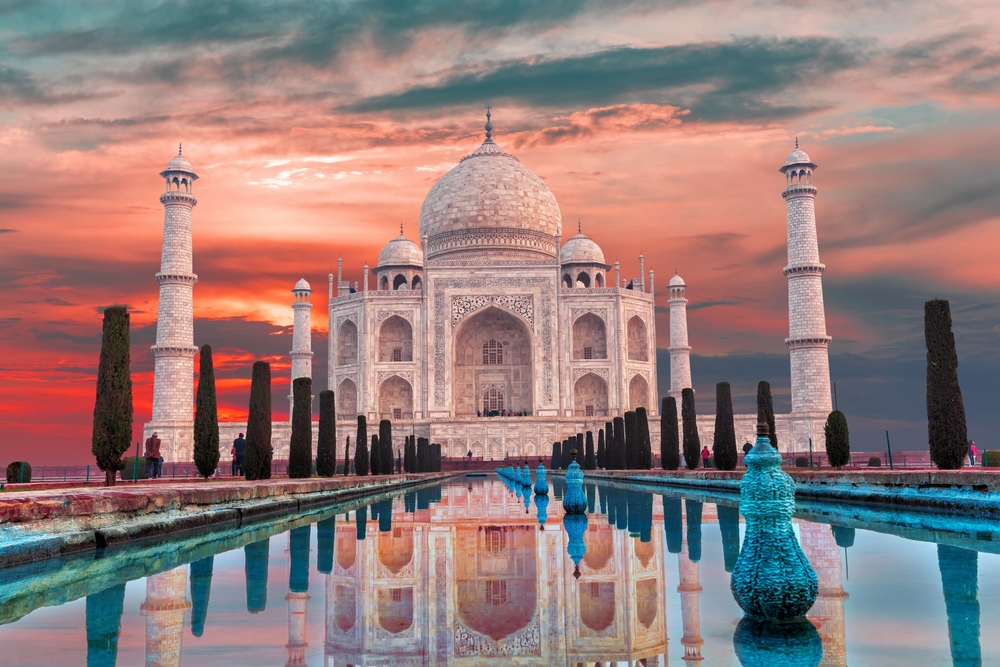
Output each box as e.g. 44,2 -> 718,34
0,0 -> 1000,465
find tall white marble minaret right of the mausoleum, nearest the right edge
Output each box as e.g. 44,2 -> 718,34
779,139 -> 832,418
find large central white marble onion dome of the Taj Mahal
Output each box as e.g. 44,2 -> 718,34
420,136 -> 562,257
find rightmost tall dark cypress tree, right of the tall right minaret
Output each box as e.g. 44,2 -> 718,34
924,299 -> 969,470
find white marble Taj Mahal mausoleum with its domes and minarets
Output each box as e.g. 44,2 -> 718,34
144,112 -> 832,462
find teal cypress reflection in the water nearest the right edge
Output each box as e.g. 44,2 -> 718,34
938,544 -> 983,667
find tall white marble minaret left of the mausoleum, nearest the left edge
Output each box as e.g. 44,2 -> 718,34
152,147 -> 198,461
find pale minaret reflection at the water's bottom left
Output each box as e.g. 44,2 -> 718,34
140,565 -> 191,667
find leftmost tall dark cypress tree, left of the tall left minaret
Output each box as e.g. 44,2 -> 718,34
91,306 -> 132,486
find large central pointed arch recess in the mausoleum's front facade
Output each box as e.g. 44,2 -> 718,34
452,306 -> 534,415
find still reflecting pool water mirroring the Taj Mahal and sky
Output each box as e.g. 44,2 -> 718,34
0,477 -> 1000,667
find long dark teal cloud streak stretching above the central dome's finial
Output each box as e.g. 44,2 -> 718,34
349,37 -> 870,120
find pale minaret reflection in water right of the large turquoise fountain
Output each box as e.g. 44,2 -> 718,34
799,521 -> 847,667
